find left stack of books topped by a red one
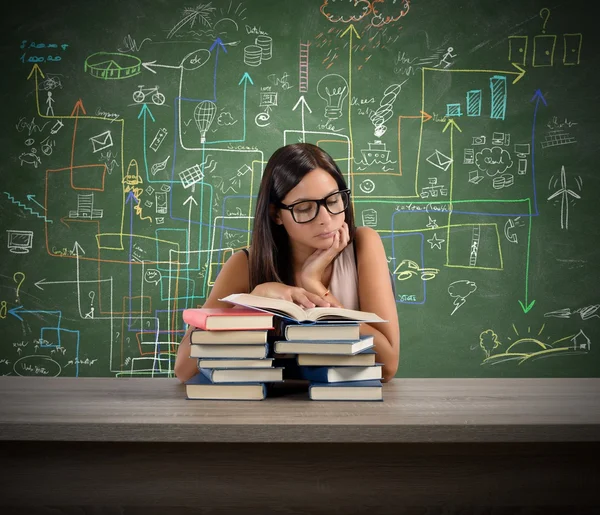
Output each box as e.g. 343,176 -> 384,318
183,308 -> 283,400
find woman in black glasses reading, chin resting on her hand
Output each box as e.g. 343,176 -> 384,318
175,143 -> 400,382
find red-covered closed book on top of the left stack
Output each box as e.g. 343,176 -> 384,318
183,308 -> 274,331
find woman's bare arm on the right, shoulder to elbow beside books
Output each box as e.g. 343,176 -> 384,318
356,227 -> 400,382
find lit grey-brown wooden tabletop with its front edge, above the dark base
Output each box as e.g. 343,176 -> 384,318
0,377 -> 600,443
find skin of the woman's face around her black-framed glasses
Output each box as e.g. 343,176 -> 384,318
276,168 -> 345,249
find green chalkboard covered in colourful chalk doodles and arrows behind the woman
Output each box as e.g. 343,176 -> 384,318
0,0 -> 600,377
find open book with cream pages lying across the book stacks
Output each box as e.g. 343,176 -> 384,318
219,293 -> 387,323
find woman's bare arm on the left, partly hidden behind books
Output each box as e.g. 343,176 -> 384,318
175,251 -> 248,383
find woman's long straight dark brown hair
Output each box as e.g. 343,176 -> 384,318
249,143 -> 356,291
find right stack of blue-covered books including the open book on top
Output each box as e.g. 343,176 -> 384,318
221,294 -> 385,401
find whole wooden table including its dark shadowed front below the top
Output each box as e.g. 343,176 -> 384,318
0,377 -> 600,515
